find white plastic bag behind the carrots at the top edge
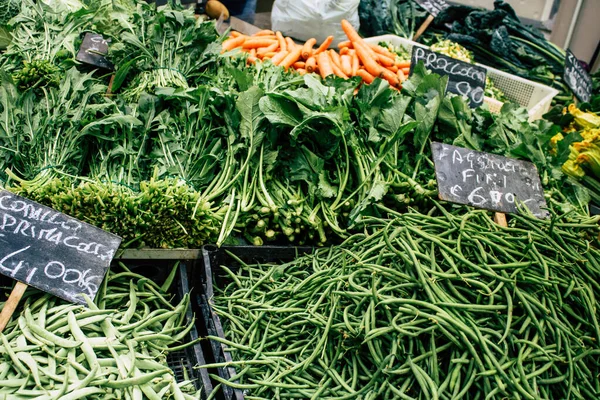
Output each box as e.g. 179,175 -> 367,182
271,0 -> 360,44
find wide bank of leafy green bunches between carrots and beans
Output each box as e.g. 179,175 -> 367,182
0,0 -> 586,248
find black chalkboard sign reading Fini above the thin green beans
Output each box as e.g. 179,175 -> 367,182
431,142 -> 547,218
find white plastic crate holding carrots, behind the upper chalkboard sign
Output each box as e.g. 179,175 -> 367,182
365,35 -> 558,121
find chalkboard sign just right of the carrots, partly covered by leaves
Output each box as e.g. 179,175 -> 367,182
410,46 -> 487,108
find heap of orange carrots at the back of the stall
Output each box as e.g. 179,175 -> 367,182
223,20 -> 410,89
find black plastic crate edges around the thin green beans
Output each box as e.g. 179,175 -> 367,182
191,246 -> 313,400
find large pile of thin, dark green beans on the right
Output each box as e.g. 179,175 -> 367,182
207,207 -> 600,400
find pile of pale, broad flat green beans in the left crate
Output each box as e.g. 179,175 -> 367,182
0,265 -> 200,400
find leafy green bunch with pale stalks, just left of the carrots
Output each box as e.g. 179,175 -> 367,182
110,4 -> 220,102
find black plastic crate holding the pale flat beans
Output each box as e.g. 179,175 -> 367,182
0,259 -> 213,399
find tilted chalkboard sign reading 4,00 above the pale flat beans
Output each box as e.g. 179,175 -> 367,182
0,190 -> 121,305
